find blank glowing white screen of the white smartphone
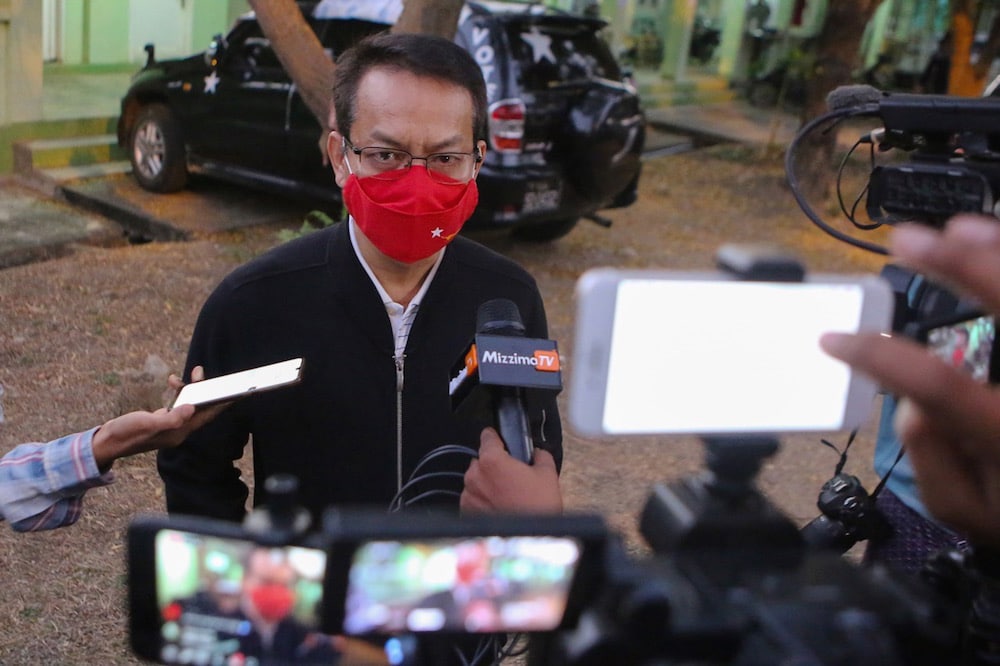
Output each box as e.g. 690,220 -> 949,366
603,279 -> 864,434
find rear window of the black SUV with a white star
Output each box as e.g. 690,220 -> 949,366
507,22 -> 621,91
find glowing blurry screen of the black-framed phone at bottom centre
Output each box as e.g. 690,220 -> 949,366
344,536 -> 581,634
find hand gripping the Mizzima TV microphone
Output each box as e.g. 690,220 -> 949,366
461,428 -> 562,513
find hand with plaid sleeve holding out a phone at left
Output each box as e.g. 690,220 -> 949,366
92,366 -> 230,471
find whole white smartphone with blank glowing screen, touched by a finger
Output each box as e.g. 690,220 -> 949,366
569,269 -> 893,436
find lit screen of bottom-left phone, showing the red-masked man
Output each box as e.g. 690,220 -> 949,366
154,529 -> 332,666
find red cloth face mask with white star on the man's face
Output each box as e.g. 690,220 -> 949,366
344,166 -> 479,264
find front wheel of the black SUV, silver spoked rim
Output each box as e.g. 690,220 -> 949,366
129,104 -> 187,192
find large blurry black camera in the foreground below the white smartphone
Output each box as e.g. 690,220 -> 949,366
531,438 -> 964,666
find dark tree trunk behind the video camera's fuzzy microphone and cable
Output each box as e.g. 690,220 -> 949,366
795,0 -> 880,202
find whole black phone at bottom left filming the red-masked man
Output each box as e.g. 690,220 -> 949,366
128,516 -> 336,665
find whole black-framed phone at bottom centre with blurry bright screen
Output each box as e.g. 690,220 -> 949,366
325,512 -> 606,636
